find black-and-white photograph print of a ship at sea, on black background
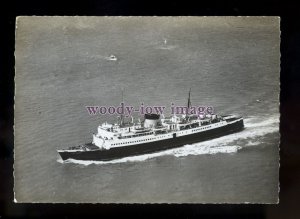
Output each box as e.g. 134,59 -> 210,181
14,16 -> 280,204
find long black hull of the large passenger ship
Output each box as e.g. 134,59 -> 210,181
59,120 -> 244,161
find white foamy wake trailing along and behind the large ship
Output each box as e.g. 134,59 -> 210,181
59,116 -> 279,165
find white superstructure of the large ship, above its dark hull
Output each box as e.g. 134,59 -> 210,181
92,114 -> 242,149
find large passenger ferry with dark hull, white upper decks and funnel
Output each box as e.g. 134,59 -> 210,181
57,91 -> 244,161
